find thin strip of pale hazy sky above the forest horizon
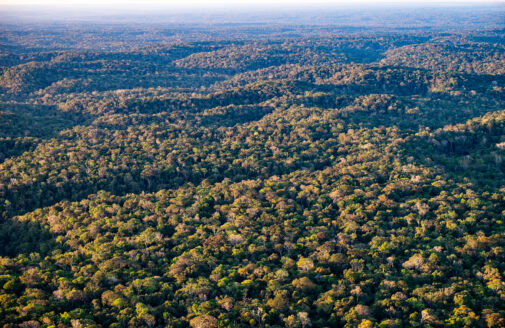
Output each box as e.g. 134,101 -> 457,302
0,0 -> 505,8
